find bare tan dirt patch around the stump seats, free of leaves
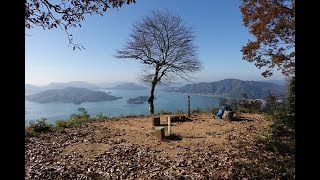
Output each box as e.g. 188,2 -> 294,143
63,113 -> 270,158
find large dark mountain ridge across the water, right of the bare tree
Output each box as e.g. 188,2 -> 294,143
164,79 -> 286,99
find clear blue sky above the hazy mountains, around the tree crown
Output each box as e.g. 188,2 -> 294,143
25,0 -> 283,85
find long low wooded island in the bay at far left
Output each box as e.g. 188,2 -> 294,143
25,87 -> 122,104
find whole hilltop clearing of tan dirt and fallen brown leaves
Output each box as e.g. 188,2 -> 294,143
25,113 -> 295,179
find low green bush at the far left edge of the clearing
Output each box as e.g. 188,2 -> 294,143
26,118 -> 53,136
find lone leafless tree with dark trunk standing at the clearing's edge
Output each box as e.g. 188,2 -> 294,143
115,10 -> 201,114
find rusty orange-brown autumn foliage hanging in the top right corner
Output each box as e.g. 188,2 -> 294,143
240,0 -> 295,77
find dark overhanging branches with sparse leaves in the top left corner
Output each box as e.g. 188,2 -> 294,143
25,0 -> 136,50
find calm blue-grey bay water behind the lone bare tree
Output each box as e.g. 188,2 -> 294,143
25,89 -> 219,124
